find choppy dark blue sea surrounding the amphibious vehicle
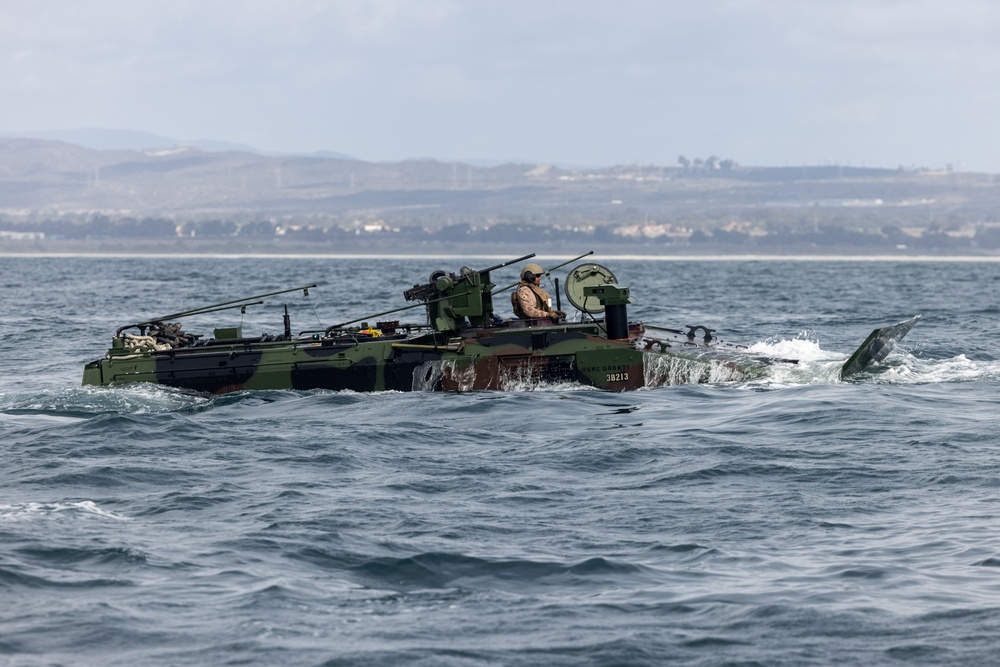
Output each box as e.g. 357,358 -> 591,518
0,255 -> 1000,667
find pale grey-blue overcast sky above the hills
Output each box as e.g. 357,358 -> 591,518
0,0 -> 1000,173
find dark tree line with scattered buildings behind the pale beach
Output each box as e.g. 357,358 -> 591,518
0,215 -> 1000,251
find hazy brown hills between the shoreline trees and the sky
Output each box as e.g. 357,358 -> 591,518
0,132 -> 1000,232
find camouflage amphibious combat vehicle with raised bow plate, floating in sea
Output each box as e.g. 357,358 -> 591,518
83,253 -> 920,394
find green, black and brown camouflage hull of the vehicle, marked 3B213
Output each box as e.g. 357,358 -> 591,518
83,325 -> 696,394
